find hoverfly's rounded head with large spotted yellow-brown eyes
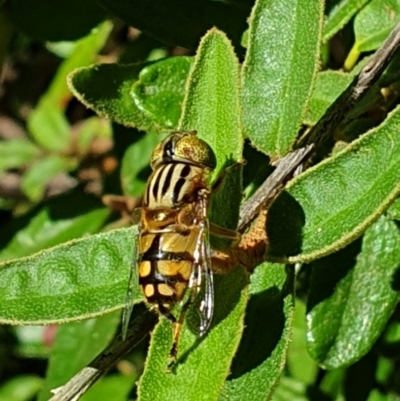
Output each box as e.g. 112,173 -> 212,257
151,131 -> 217,170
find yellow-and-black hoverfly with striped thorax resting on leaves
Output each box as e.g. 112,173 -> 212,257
123,131 -> 238,365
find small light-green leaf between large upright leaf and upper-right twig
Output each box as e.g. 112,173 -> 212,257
304,71 -> 353,125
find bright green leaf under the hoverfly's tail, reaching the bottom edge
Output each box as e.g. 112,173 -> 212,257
138,268 -> 247,401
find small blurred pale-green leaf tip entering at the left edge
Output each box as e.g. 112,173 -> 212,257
0,139 -> 40,172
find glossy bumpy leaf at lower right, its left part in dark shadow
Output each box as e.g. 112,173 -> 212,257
307,216 -> 400,369
